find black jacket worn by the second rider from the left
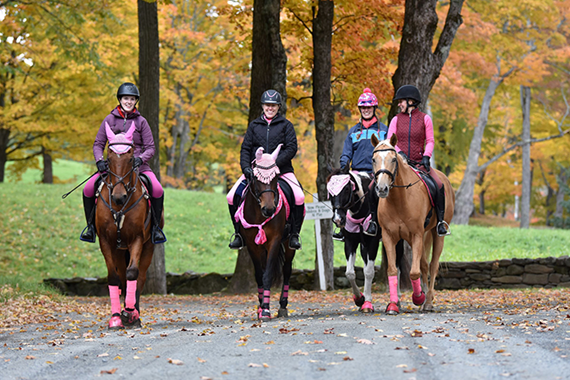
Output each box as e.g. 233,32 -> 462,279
240,114 -> 297,174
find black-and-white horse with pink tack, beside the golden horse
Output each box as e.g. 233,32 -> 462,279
327,169 -> 381,313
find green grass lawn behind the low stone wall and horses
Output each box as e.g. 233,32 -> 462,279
0,161 -> 570,296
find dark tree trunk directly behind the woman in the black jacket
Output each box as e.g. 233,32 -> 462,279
226,0 -> 287,293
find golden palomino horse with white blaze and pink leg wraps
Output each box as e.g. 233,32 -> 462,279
371,134 -> 455,314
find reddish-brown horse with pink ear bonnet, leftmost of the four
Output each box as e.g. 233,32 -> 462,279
95,122 -> 164,329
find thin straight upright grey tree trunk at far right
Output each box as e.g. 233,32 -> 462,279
520,86 -> 531,228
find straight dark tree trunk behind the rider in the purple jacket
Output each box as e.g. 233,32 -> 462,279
138,0 -> 166,294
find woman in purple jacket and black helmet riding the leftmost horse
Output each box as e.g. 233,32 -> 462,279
80,83 -> 166,244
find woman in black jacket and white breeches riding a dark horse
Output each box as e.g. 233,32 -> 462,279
227,90 -> 305,249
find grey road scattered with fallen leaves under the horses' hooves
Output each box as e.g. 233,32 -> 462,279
0,292 -> 570,380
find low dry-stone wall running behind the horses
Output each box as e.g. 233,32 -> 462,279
44,256 -> 570,296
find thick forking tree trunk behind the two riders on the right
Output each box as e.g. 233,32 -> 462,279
388,0 -> 464,120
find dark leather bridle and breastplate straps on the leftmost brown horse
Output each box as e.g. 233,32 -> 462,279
96,142 -> 148,248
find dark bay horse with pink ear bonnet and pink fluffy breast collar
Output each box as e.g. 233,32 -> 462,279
235,144 -> 295,321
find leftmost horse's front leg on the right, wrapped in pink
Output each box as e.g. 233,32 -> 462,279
121,238 -> 144,327
